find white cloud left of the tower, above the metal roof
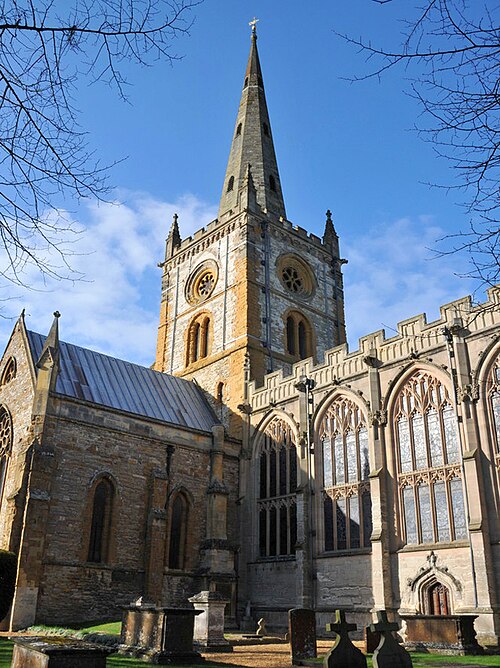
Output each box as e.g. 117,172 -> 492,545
0,193 -> 216,365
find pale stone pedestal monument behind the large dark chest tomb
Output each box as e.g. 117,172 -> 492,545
188,591 -> 233,652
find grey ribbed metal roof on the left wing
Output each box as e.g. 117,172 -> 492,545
27,331 -> 218,431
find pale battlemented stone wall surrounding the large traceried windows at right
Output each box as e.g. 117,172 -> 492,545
241,289 -> 500,644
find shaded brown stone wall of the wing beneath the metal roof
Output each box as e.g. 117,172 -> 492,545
0,314 -> 238,629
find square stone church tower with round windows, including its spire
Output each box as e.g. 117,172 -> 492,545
154,26 -> 345,437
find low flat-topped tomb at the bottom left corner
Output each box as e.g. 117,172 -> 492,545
11,636 -> 113,668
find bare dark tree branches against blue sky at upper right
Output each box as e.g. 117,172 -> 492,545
340,0 -> 500,285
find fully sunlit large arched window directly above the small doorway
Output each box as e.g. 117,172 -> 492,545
393,371 -> 467,544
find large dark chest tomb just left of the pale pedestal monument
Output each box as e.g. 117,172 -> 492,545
118,603 -> 203,664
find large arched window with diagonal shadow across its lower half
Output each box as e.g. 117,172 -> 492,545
319,397 -> 372,551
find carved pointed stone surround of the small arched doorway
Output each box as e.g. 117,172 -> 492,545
400,551 -> 463,615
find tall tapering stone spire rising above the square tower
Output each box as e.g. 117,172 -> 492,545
219,21 -> 286,219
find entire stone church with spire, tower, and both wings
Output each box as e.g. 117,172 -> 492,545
0,26 -> 500,645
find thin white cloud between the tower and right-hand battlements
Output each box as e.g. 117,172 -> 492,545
342,216 -> 474,350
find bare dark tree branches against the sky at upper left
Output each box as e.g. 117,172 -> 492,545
0,0 -> 201,284
